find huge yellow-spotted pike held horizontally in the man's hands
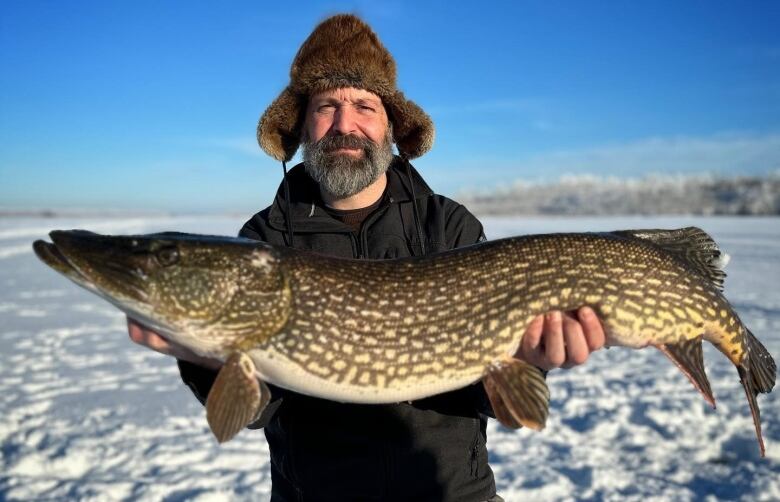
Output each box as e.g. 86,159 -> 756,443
34,228 -> 776,456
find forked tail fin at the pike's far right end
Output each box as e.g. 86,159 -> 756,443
737,328 -> 777,457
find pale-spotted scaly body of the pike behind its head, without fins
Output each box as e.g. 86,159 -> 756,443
257,234 -> 742,400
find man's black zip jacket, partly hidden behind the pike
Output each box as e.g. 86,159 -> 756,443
180,159 -> 495,502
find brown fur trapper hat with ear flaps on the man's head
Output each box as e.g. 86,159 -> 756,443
257,14 -> 434,161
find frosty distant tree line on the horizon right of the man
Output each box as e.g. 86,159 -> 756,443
459,172 -> 780,215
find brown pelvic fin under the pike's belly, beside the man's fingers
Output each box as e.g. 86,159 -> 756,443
482,358 -> 550,430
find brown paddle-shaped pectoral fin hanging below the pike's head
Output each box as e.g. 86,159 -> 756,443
206,352 -> 271,443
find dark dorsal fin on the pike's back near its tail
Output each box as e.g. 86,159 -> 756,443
612,227 -> 728,291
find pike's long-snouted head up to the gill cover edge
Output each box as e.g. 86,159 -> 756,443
34,230 -> 290,355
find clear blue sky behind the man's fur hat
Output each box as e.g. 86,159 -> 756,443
0,0 -> 780,214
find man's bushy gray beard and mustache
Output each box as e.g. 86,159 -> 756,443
303,127 -> 393,199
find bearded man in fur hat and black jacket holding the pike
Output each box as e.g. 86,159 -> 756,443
129,15 -> 604,502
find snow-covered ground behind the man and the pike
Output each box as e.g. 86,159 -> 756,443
0,217 -> 780,501
